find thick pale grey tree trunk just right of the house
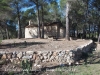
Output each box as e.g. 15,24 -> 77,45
66,2 -> 70,40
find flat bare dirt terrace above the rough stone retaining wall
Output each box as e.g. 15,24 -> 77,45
0,38 -> 89,52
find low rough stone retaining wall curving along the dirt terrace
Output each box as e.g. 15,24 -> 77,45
0,40 -> 93,69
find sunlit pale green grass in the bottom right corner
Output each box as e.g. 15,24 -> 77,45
43,63 -> 100,75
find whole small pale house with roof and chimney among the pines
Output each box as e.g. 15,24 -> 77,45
25,22 -> 66,38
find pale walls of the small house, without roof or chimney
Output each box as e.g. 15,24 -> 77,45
25,25 -> 65,38
